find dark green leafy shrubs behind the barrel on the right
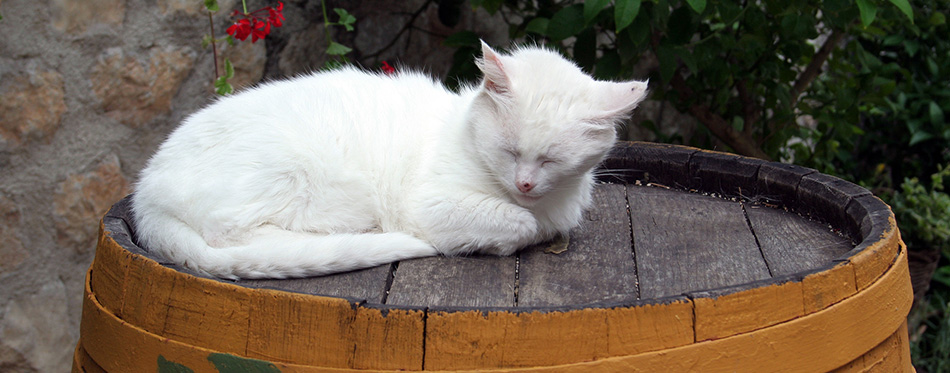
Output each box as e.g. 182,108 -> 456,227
436,0 -> 950,366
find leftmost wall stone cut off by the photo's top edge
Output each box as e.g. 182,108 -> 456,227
50,0 -> 126,34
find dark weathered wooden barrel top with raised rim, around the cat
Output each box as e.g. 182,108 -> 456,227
103,143 -> 892,311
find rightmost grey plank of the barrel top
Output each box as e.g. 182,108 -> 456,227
746,205 -> 853,276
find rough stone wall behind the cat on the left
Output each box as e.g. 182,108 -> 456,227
0,0 -> 506,372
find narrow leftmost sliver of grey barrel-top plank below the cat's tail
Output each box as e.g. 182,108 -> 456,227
235,264 -> 391,303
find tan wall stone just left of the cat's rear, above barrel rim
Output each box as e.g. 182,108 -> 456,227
53,154 -> 130,253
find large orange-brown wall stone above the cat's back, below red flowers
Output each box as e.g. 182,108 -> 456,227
90,47 -> 195,127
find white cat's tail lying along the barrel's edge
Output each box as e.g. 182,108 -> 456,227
137,212 -> 438,279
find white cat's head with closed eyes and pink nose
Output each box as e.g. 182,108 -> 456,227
468,43 -> 647,207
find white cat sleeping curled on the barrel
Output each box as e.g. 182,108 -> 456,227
132,43 -> 647,279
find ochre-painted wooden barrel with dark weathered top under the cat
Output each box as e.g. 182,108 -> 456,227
73,143 -> 913,372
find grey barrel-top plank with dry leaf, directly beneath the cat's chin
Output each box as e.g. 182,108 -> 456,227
518,184 -> 637,307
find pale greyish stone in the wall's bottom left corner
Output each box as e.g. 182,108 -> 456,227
0,279 -> 76,372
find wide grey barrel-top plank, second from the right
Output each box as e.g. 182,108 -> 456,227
627,185 -> 770,299
